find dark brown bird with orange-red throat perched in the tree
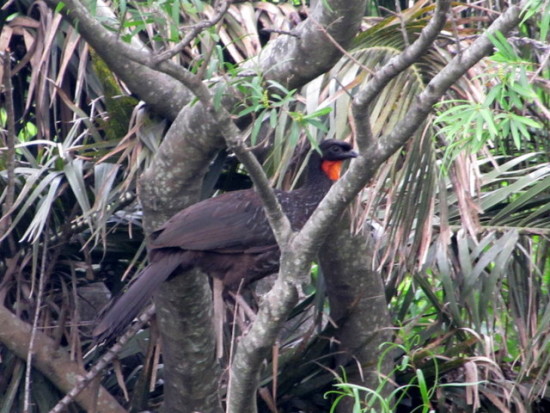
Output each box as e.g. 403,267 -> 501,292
93,140 -> 357,341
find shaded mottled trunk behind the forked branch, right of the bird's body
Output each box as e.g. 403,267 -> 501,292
319,220 -> 393,412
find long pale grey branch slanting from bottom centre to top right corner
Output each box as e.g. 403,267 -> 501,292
229,0 -> 520,412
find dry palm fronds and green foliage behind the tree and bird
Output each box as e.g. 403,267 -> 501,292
0,0 -> 550,411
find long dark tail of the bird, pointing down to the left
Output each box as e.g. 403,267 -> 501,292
92,251 -> 185,342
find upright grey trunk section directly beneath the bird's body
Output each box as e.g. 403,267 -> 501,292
155,271 -> 223,413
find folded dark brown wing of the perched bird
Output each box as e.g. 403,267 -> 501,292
150,190 -> 275,253
